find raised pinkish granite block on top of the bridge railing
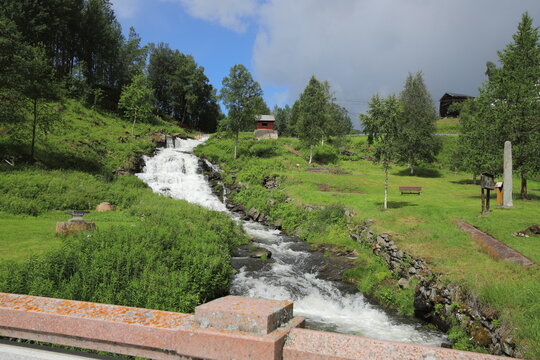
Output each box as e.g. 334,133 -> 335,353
195,296 -> 293,335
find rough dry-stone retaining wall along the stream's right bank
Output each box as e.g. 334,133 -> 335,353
349,225 -> 520,357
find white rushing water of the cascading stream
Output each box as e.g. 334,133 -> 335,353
137,138 -> 444,346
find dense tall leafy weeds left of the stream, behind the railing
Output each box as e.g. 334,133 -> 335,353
0,191 -> 244,312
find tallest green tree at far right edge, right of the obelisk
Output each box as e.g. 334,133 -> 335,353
490,13 -> 540,199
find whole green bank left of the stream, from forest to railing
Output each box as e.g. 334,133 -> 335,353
0,101 -> 246,312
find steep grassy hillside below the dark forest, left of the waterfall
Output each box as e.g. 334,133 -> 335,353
0,100 -> 184,177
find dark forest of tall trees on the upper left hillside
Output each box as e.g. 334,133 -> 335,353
0,0 -> 223,158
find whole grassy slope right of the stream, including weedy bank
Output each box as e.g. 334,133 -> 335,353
197,134 -> 540,358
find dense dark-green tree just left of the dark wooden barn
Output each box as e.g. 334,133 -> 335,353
397,72 -> 441,175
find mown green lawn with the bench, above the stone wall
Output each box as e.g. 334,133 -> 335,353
197,136 -> 540,358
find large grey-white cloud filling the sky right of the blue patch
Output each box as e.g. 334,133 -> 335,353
253,0 -> 540,112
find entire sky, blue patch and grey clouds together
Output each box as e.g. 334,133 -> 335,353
111,0 -> 540,126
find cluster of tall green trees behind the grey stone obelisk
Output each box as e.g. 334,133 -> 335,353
461,13 -> 540,198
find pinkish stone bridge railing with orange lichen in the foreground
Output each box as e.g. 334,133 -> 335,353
0,293 -> 503,360
